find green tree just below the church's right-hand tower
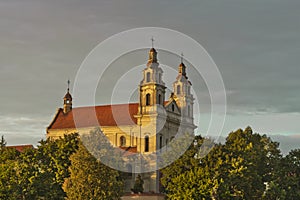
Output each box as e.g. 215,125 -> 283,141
161,134 -> 215,199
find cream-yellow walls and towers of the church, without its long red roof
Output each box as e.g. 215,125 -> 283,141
47,48 -> 196,193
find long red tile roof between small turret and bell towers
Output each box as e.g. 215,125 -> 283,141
48,103 -> 139,129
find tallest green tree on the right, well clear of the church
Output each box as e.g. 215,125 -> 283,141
213,127 -> 281,199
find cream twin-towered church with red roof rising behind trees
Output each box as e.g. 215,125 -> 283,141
46,47 -> 196,193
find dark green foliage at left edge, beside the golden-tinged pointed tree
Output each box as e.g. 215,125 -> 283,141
0,134 -> 78,199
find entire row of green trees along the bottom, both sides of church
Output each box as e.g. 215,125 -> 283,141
0,127 -> 300,200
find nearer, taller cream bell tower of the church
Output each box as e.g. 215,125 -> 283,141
135,45 -> 166,153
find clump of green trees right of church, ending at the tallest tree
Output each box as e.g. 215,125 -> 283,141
161,127 -> 281,199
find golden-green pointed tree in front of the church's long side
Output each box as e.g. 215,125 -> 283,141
63,143 -> 123,200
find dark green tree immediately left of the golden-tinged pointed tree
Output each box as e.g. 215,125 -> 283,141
28,133 -> 79,199
